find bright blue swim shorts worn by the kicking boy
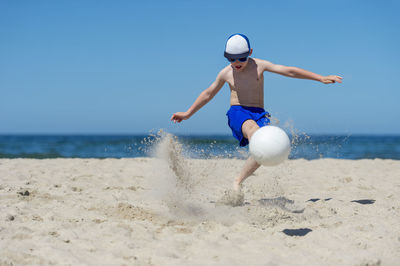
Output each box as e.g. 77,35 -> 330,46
226,105 -> 271,146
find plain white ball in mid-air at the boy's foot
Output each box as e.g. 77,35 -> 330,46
249,126 -> 290,166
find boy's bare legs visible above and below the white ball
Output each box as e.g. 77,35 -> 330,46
233,120 -> 260,190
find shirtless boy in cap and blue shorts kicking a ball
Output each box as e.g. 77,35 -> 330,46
171,34 -> 342,191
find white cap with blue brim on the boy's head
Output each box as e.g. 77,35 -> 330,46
224,33 -> 250,59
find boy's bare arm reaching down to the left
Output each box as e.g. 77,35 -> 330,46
171,71 -> 225,123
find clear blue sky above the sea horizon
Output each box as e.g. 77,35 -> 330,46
0,0 -> 400,134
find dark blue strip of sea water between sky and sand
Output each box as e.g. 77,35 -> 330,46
0,135 -> 400,160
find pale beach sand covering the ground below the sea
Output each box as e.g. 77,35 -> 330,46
0,138 -> 400,265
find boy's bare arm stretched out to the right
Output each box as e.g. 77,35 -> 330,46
261,60 -> 342,84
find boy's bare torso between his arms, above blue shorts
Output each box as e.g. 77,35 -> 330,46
223,58 -> 264,108
